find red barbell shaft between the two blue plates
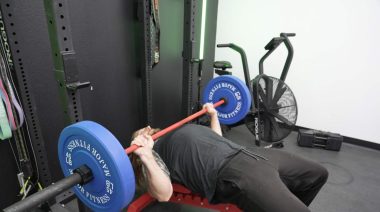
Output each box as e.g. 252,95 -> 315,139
125,99 -> 226,154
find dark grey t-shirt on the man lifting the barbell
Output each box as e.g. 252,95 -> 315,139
153,124 -> 244,201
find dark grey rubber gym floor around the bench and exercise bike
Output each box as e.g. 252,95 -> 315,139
53,126 -> 380,212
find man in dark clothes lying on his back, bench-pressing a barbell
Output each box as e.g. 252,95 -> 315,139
132,104 -> 328,212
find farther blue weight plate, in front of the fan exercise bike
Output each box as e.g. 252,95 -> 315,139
203,75 -> 252,125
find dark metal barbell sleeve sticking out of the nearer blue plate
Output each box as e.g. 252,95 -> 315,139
4,165 -> 93,212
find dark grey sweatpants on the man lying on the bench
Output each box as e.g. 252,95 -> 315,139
212,149 -> 328,212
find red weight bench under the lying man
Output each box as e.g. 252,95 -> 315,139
127,184 -> 241,212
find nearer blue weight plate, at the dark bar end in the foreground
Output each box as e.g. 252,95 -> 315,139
58,121 -> 135,211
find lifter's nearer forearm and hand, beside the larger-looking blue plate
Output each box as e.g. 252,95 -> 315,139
131,134 -> 173,202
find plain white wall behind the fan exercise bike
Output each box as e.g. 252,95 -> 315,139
215,0 -> 380,143
